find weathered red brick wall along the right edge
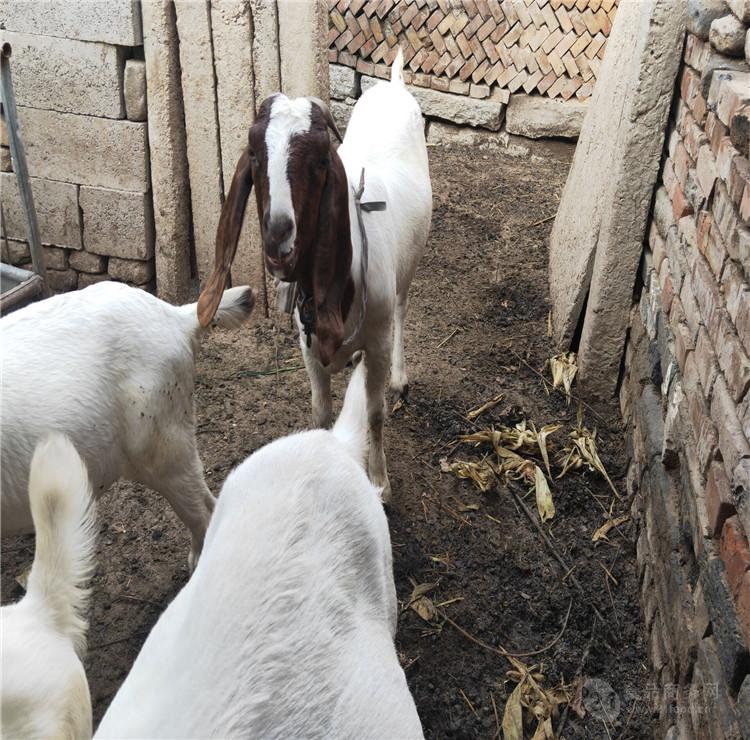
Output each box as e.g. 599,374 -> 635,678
620,0 -> 750,738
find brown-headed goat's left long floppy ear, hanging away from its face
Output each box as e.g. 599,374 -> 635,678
198,149 -> 253,327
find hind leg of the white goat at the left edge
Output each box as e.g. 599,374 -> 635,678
151,444 -> 216,572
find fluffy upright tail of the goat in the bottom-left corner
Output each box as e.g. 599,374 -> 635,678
27,434 -> 96,655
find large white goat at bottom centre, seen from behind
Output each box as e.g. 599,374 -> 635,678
97,366 -> 422,740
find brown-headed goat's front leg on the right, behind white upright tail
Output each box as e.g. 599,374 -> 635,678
365,334 -> 391,504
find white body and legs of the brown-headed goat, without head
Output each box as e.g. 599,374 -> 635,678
297,50 -> 432,501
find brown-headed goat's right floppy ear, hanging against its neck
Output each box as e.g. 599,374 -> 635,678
312,148 -> 354,366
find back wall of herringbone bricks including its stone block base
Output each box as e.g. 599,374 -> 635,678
328,0 -> 617,145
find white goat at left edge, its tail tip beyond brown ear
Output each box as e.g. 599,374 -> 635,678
0,282 -> 253,564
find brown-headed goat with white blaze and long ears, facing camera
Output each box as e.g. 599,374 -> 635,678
198,50 -> 432,502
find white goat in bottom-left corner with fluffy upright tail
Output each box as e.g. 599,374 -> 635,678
0,435 -> 95,738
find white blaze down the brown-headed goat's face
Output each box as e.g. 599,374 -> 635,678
266,95 -> 312,230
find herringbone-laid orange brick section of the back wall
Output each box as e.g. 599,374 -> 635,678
328,0 -> 617,100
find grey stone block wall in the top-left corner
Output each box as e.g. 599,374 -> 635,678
0,0 -> 154,291
